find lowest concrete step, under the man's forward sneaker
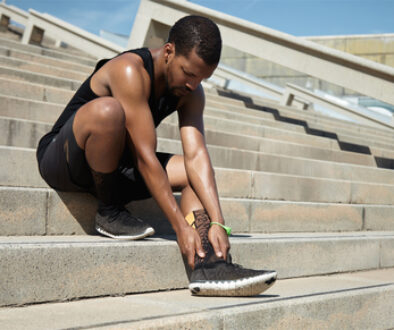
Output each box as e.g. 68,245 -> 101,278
0,268 -> 394,330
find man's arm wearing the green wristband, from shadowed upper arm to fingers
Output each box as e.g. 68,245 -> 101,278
178,85 -> 230,258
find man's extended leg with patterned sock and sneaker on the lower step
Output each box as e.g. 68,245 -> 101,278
166,156 -> 276,296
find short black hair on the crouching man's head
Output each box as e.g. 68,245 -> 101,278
167,15 -> 222,65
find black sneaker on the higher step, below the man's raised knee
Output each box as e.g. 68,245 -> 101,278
96,206 -> 155,240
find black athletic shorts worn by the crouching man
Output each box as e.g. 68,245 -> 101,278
39,114 -> 173,203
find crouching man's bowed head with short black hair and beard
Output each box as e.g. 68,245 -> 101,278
164,16 -> 222,96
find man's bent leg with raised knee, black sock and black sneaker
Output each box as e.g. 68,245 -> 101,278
73,97 -> 154,239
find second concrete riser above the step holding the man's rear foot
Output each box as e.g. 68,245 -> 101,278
0,146 -> 394,205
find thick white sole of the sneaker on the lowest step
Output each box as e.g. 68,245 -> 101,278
189,272 -> 277,297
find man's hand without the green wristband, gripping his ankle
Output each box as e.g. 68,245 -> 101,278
177,226 -> 205,269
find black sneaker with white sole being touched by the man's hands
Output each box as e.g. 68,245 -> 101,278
189,257 -> 277,297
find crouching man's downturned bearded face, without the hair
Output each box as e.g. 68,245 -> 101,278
167,44 -> 217,97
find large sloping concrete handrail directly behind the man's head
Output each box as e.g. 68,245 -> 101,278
129,0 -> 394,104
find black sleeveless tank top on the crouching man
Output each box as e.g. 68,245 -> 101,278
37,48 -> 179,162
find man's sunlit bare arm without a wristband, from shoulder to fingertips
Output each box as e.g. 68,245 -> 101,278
109,55 -> 204,266
